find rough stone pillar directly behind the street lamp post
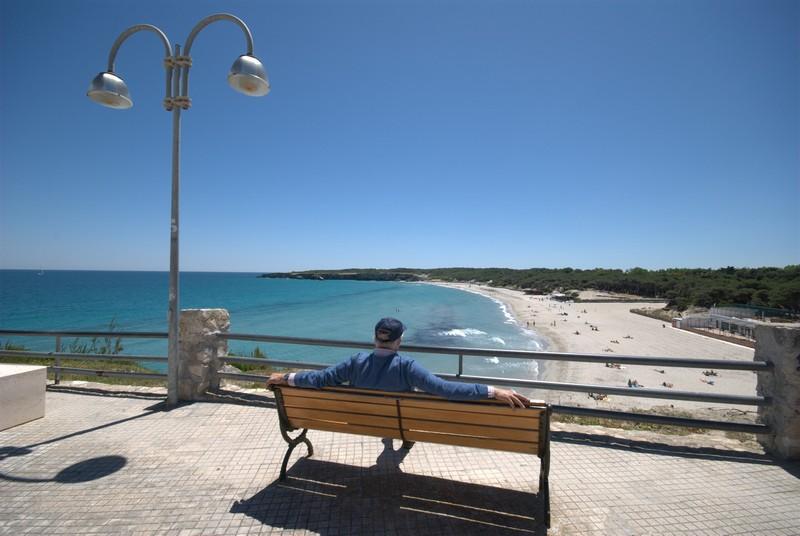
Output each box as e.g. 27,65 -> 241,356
178,309 -> 231,400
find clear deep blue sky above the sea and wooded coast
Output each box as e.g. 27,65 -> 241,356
0,0 -> 800,271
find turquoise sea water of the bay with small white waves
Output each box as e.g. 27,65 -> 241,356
0,270 -> 542,379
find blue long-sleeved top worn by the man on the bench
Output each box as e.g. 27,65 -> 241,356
289,349 -> 489,400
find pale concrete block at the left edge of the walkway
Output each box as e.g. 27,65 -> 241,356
0,364 -> 47,430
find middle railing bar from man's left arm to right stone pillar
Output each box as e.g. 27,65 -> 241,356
444,374 -> 771,406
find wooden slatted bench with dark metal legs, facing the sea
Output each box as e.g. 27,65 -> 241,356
271,385 -> 550,527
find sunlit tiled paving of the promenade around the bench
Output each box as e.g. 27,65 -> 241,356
0,387 -> 800,536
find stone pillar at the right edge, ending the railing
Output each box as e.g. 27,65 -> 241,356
754,325 -> 800,460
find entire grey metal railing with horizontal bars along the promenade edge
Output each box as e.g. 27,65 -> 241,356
0,330 -> 772,434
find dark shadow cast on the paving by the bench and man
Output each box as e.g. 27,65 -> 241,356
230,449 -> 546,536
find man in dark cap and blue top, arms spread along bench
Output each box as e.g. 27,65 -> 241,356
267,318 -> 530,408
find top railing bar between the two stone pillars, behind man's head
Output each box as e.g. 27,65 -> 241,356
219,333 -> 771,370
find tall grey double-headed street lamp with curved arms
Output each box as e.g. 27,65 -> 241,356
86,13 -> 270,405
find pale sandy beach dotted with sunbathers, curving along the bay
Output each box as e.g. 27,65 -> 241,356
437,283 -> 756,420
